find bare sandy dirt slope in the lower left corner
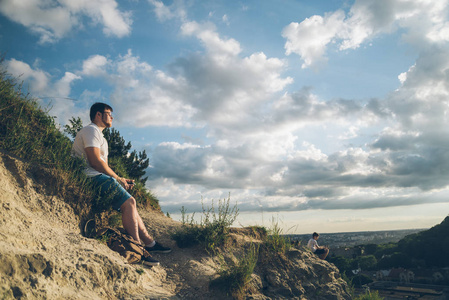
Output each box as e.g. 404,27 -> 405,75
0,153 -> 181,299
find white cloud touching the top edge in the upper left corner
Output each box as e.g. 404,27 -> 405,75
0,0 -> 131,43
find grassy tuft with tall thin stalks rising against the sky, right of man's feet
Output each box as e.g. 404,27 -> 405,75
172,196 -> 238,251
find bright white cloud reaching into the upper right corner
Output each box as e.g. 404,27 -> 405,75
282,0 -> 449,68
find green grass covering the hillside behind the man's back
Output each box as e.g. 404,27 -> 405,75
0,60 -> 93,217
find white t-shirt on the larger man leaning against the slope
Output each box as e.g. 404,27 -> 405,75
72,123 -> 109,177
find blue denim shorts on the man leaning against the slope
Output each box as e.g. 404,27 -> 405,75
91,174 -> 132,211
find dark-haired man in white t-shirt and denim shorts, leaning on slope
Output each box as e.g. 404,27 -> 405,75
72,103 -> 171,266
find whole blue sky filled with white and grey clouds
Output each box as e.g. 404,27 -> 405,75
0,0 -> 449,233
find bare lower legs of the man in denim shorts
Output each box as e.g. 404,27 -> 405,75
120,197 -> 153,245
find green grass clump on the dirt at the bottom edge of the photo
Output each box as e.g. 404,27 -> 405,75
211,244 -> 259,299
